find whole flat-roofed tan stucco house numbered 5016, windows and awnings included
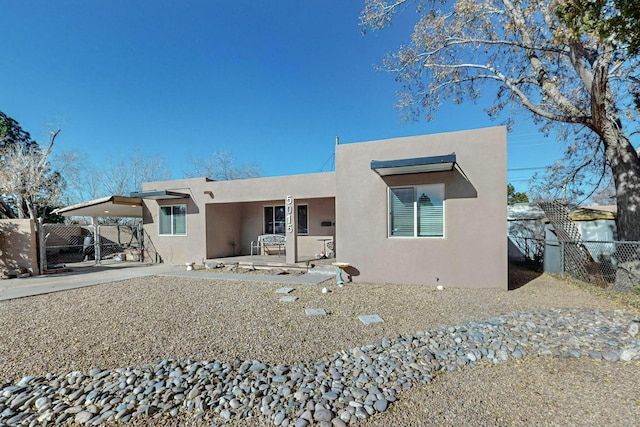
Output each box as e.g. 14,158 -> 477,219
132,127 -> 507,289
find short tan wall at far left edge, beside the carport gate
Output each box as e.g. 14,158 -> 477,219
0,219 -> 39,274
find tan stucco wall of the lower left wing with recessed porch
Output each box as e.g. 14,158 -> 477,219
143,172 -> 335,264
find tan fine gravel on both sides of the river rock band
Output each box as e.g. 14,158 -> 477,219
0,272 -> 640,426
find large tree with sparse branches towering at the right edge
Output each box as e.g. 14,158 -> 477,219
361,0 -> 640,241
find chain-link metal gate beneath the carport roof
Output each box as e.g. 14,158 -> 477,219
39,222 -> 143,271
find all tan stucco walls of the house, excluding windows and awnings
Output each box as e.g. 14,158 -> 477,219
143,127 -> 507,289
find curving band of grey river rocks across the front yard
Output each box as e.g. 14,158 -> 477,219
0,270 -> 640,426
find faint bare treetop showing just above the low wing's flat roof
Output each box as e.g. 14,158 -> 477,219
185,151 -> 263,181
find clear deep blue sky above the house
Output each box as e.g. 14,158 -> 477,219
0,0 -> 561,195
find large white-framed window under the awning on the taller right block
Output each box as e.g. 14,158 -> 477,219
389,184 -> 444,237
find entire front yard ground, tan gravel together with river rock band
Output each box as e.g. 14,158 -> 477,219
0,270 -> 640,426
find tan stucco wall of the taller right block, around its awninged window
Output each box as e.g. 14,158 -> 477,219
336,127 -> 507,289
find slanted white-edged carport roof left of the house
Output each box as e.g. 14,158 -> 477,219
53,196 -> 142,218
